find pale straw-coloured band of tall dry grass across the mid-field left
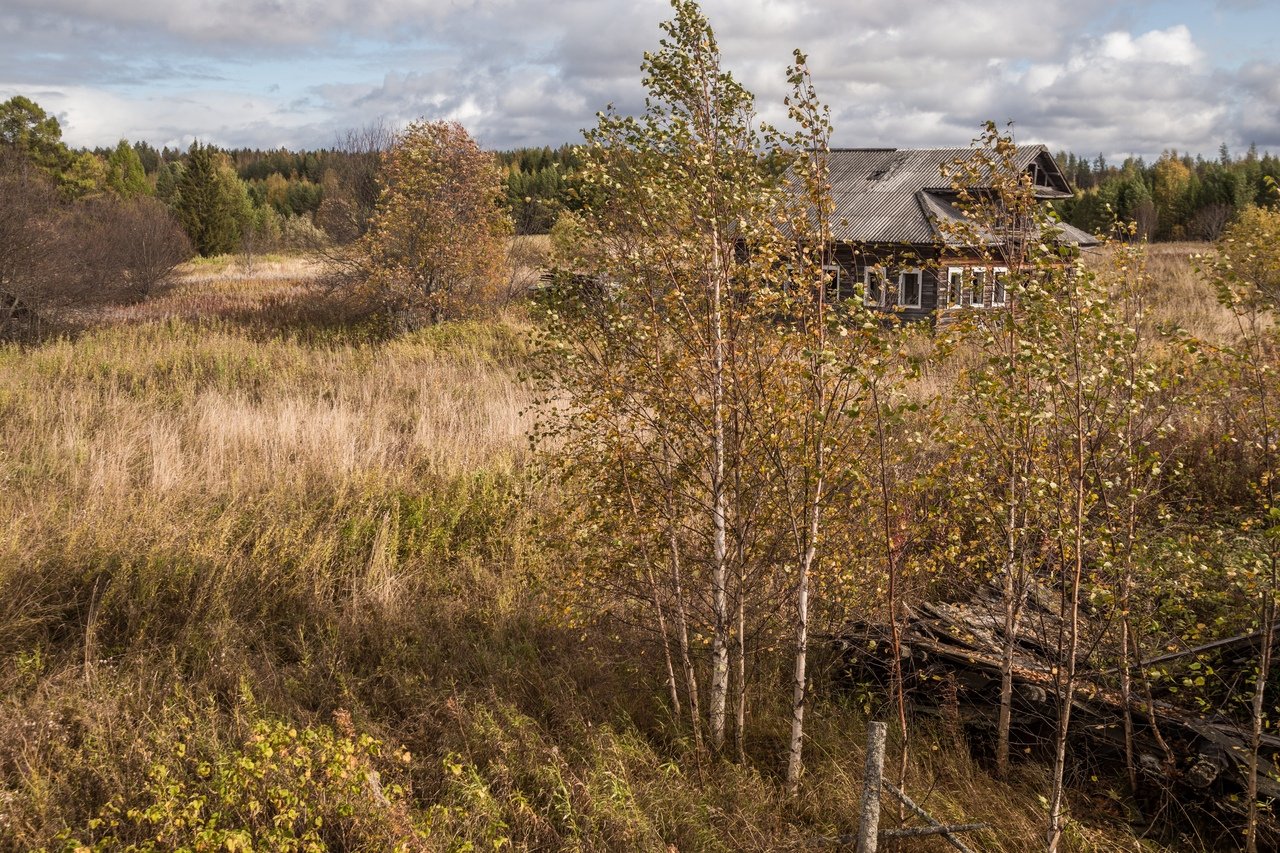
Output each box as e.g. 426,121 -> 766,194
0,321 -> 527,499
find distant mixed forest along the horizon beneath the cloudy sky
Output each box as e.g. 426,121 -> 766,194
0,97 -> 1280,245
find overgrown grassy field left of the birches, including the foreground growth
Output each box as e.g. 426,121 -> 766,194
0,254 -> 1198,852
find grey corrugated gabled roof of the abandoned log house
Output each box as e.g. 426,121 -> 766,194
827,145 -> 1097,246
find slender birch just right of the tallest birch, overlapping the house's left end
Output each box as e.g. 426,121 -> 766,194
762,51 -> 885,795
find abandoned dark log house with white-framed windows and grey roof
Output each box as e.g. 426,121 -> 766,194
828,145 -> 1097,320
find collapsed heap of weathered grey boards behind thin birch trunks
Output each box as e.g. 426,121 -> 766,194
837,587 -> 1280,849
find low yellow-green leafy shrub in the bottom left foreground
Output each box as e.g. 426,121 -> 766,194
64,711 -> 426,850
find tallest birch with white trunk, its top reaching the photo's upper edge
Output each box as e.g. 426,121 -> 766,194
532,1 -> 777,749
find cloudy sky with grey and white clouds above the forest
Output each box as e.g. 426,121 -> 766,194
0,0 -> 1280,159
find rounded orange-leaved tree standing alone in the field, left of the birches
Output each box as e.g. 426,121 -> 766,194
356,122 -> 511,320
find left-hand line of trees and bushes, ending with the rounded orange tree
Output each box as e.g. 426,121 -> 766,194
0,96 -> 527,332
